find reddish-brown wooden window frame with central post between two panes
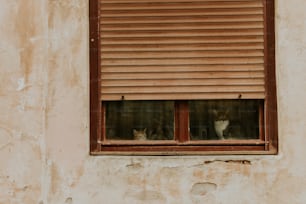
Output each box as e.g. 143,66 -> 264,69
89,0 -> 278,155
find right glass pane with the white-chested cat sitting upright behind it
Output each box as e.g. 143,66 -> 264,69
189,100 -> 262,140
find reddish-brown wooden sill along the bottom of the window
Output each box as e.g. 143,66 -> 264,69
91,143 -> 277,156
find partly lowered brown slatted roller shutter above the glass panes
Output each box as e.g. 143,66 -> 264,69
99,0 -> 265,100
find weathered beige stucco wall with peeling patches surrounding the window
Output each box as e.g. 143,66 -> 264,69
0,0 -> 306,204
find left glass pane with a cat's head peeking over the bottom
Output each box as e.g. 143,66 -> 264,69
104,101 -> 174,140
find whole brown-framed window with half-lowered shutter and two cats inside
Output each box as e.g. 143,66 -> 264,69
89,0 -> 278,155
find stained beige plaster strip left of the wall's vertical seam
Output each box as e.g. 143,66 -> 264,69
0,0 -> 47,203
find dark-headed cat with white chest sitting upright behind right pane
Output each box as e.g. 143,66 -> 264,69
212,109 -> 230,140
